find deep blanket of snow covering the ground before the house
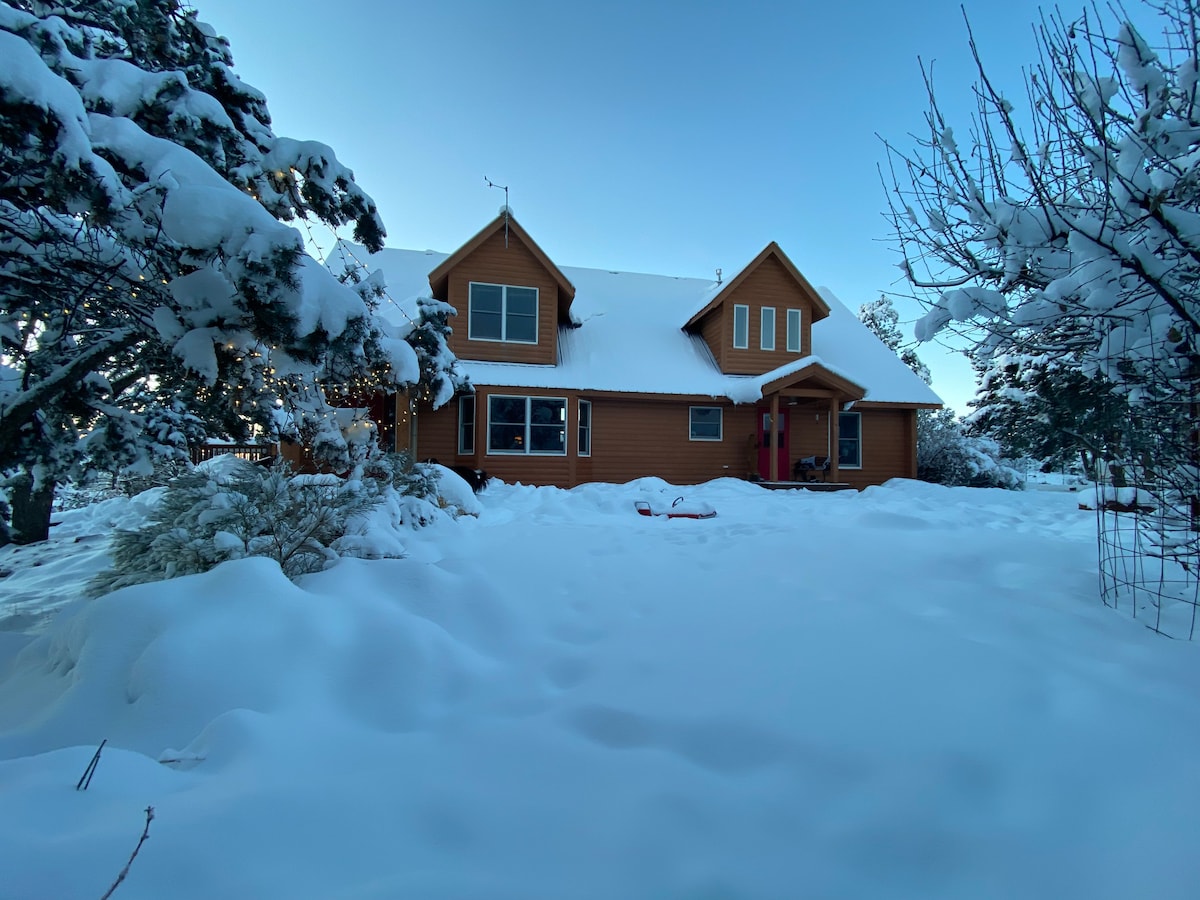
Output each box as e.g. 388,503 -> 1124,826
0,480 -> 1200,900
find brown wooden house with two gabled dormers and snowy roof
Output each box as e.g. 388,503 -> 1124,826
336,212 -> 941,487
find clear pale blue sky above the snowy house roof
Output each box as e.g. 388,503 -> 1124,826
194,0 -> 1066,412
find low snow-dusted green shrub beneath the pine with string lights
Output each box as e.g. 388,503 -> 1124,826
90,455 -> 475,595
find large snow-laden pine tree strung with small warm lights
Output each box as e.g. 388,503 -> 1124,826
0,0 -> 434,541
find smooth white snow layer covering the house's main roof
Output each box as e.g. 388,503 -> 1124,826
331,247 -> 942,403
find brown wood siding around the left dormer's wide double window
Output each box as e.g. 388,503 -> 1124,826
438,230 -> 558,366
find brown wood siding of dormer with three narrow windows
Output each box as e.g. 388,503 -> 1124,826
701,257 -> 812,374
